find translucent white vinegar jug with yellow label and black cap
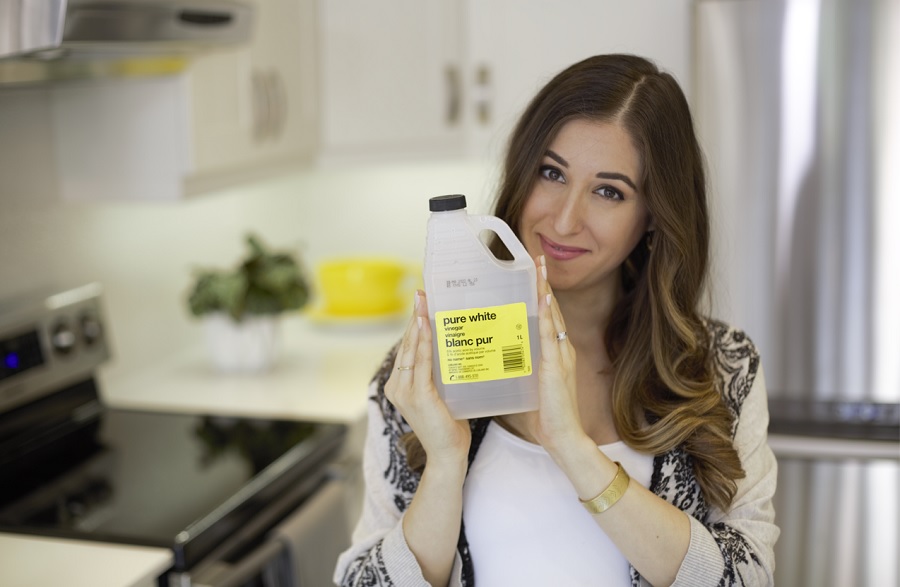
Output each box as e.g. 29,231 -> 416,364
424,195 -> 541,419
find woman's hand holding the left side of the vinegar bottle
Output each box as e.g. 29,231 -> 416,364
384,291 -> 472,465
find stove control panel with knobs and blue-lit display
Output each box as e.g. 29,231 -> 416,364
0,284 -> 109,413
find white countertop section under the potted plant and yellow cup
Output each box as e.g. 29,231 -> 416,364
100,317 -> 404,423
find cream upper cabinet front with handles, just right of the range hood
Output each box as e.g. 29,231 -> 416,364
190,0 -> 316,191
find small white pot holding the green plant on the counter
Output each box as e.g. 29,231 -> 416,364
203,313 -> 278,373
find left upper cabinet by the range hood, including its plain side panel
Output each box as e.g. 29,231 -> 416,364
51,0 -> 317,200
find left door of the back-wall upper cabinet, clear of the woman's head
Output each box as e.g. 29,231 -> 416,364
318,0 -> 463,162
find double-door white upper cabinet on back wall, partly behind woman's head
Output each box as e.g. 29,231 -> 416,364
318,0 -> 691,161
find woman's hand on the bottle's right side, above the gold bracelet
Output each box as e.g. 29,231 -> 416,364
525,256 -> 584,454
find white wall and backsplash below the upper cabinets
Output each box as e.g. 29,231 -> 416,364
0,89 -> 493,382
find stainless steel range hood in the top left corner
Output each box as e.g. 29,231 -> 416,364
0,0 -> 254,84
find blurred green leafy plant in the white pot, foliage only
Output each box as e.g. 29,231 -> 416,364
188,234 -> 309,320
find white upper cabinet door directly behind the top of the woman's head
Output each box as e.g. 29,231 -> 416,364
464,0 -> 692,162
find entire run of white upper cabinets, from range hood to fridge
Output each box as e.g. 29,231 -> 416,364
54,0 -> 692,199
